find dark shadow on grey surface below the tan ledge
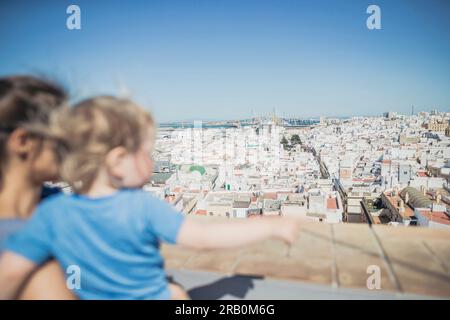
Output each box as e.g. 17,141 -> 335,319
188,276 -> 263,300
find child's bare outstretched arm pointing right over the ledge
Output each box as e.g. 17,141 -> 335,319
177,217 -> 299,249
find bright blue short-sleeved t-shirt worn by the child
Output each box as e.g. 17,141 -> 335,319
5,190 -> 184,299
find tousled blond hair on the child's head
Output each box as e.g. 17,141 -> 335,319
50,96 -> 155,193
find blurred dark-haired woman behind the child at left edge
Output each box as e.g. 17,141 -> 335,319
0,76 -> 74,299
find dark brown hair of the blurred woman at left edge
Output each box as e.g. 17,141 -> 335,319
0,76 -> 67,188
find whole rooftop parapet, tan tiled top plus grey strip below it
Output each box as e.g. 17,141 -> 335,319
162,218 -> 450,299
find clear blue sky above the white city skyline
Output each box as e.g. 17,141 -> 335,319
0,0 -> 450,122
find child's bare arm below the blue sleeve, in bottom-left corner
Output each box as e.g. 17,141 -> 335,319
0,251 -> 37,300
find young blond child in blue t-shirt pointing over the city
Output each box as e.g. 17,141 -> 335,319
0,96 -> 298,299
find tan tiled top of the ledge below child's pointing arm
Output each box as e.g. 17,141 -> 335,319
162,218 -> 450,298
